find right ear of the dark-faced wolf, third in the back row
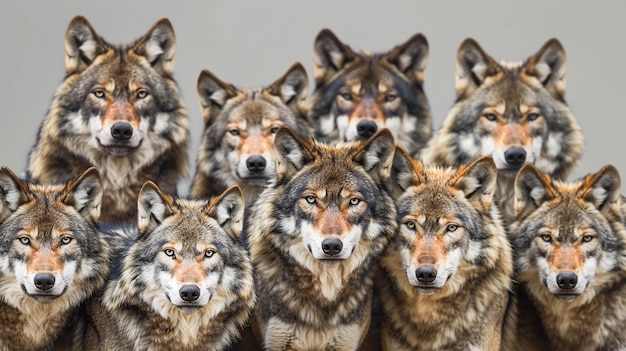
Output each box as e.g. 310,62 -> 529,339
387,33 -> 428,85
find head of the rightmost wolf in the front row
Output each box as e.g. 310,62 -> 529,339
510,165 -> 626,301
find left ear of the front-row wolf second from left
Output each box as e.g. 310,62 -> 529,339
137,180 -> 174,235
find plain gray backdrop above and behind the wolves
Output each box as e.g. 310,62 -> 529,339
0,0 -> 626,192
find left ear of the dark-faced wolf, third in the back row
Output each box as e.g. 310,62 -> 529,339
313,28 -> 357,85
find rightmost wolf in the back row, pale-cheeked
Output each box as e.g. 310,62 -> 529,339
420,38 -> 584,225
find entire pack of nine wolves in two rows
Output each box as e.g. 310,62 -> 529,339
0,16 -> 626,351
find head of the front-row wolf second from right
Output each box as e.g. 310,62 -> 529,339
392,148 -> 506,295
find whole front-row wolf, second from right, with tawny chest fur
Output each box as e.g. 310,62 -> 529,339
377,147 -> 513,351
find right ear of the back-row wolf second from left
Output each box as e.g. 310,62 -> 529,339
268,62 -> 309,112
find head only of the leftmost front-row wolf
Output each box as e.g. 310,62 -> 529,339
0,167 -> 109,309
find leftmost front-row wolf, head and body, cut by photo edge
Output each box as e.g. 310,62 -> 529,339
0,167 -> 109,351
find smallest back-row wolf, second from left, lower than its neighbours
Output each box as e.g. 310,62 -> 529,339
189,62 -> 311,202
